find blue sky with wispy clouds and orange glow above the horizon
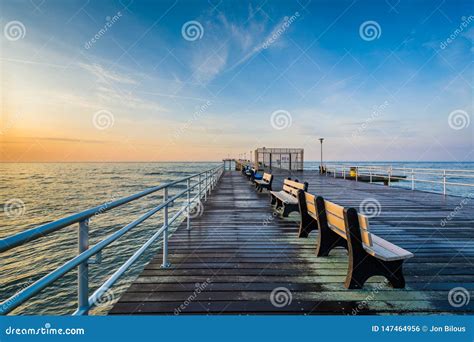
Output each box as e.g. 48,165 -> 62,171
0,0 -> 474,162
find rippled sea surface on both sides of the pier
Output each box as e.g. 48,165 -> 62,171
0,162 -> 474,315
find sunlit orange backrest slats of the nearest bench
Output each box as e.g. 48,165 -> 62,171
324,200 -> 372,247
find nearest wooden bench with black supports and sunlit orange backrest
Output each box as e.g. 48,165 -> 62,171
298,191 -> 413,289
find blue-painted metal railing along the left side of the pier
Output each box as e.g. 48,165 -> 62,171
0,165 -> 224,315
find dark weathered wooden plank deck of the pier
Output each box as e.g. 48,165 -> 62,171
109,170 -> 474,315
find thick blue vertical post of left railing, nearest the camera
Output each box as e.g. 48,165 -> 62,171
77,219 -> 89,315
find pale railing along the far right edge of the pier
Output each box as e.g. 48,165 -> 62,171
325,164 -> 474,195
